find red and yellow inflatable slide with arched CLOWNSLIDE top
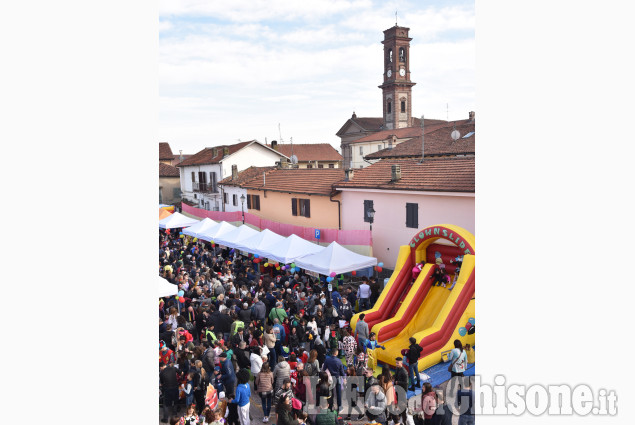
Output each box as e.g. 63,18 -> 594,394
351,224 -> 474,370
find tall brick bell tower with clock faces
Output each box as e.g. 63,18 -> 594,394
379,25 -> 416,129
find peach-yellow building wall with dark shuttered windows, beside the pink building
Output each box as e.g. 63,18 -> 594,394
247,189 -> 341,229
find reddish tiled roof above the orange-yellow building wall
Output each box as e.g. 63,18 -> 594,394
242,168 -> 344,195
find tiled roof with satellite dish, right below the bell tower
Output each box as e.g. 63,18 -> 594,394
365,122 -> 476,159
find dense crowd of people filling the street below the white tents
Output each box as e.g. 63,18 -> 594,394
159,230 -> 467,425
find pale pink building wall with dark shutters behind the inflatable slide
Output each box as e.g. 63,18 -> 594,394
342,189 -> 475,269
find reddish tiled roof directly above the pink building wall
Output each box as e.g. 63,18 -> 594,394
333,157 -> 474,193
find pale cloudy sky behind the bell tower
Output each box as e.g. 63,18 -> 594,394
158,0 -> 476,154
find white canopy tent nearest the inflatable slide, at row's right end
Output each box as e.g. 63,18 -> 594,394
295,242 -> 377,276
